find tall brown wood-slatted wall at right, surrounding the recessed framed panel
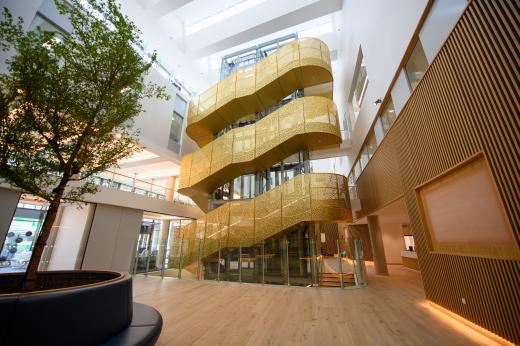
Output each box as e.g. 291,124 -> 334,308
358,0 -> 520,343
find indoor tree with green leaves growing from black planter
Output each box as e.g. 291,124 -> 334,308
0,0 -> 168,291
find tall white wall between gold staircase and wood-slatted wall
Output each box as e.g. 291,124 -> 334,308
334,0 -> 427,172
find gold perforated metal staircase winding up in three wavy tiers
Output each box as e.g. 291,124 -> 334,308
176,39 -> 352,267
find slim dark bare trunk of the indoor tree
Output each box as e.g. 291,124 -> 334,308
21,183 -> 66,292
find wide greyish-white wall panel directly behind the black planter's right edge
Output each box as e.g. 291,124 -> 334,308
81,204 -> 143,272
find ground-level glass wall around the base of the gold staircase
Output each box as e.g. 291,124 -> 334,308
131,219 -> 364,287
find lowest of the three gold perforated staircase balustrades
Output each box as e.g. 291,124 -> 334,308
174,173 -> 352,267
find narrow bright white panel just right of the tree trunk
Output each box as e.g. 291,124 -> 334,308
48,204 -> 96,270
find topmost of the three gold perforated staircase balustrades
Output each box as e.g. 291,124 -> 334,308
186,38 -> 332,146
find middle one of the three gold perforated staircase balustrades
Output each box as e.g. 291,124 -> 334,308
179,96 -> 341,211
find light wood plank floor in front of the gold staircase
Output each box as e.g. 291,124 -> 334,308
134,266 -> 495,345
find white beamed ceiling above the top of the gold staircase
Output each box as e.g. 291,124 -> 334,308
119,0 -> 342,93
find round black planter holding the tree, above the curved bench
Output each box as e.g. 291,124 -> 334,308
0,271 -> 133,345
